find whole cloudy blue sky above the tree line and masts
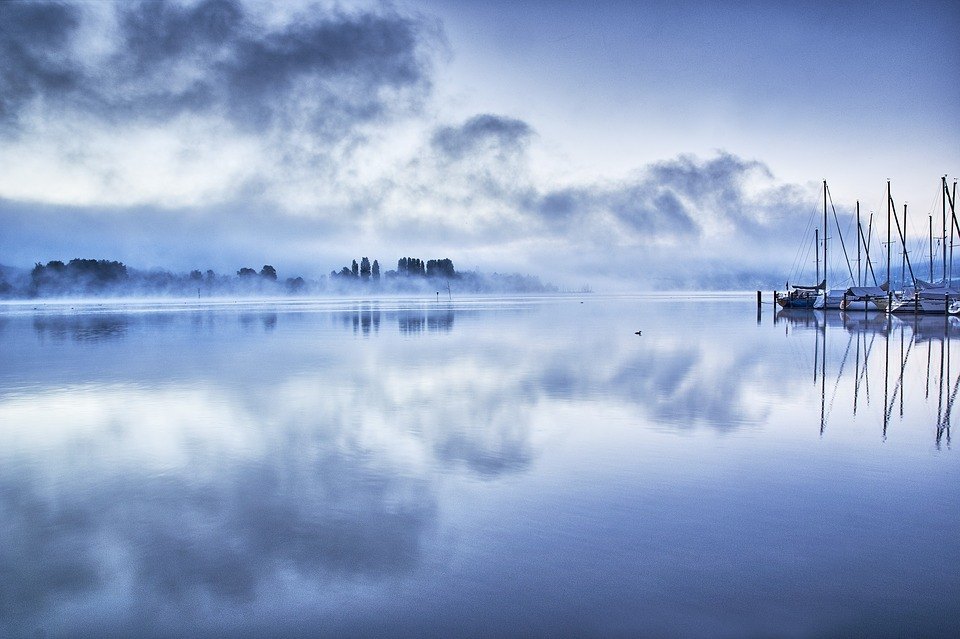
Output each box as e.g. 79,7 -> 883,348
0,0 -> 960,290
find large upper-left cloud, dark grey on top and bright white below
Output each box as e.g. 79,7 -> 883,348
0,0 -> 445,215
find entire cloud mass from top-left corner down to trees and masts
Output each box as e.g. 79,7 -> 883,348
0,0 -> 824,286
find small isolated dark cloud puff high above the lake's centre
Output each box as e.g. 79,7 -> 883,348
431,113 -> 533,160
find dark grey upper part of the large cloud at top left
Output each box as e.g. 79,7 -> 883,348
0,0 -> 437,137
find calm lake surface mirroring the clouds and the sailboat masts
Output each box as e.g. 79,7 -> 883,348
0,295 -> 960,637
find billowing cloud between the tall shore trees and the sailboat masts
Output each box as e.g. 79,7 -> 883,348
368,142 -> 815,288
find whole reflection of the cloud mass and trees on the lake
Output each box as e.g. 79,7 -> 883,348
0,303 -> 956,635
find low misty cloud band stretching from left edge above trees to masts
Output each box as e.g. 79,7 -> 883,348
0,142 -> 816,288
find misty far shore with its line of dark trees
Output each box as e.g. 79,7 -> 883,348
0,257 -> 558,299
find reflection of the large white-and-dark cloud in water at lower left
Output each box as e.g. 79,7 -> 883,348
0,380 -> 437,634
